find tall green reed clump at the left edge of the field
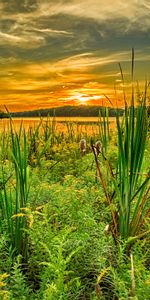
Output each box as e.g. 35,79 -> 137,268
0,119 -> 29,258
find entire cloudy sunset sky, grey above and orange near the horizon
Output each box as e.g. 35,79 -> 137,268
0,0 -> 150,111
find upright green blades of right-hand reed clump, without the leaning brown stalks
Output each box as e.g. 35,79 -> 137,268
116,88 -> 150,238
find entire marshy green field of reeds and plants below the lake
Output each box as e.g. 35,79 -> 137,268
0,104 -> 150,300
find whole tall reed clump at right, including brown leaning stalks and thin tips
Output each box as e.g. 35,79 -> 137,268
92,53 -> 150,241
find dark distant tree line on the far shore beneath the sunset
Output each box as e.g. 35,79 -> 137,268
11,105 -> 124,117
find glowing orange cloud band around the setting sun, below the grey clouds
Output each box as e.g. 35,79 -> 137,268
0,52 -> 148,111
